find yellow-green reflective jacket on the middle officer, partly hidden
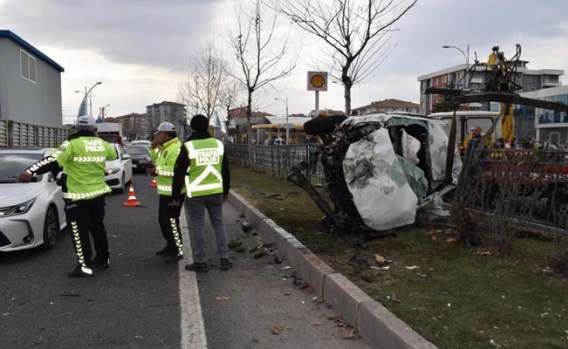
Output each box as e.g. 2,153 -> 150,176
154,137 -> 185,196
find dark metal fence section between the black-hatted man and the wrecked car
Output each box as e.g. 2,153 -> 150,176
226,144 -> 322,179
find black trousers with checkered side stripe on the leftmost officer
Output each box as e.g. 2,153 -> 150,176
65,196 -> 110,267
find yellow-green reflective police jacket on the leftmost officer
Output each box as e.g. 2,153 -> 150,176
51,136 -> 117,201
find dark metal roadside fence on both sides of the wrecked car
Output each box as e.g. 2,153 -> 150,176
227,144 -> 568,235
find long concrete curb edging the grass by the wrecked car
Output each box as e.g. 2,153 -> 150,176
229,190 -> 436,349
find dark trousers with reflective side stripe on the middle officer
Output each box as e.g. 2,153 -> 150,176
158,195 -> 185,256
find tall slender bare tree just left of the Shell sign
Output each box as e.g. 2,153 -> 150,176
228,0 -> 296,165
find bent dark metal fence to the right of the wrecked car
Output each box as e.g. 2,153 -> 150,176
452,145 -> 568,257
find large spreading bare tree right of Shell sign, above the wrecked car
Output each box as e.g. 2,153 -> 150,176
277,0 -> 417,115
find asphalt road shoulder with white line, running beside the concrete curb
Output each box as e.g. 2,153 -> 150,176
178,192 -> 370,349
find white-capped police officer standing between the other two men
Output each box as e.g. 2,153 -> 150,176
148,122 -> 185,263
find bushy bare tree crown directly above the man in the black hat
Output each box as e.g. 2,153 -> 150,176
179,43 -> 225,119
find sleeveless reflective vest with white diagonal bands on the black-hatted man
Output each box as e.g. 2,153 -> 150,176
185,138 -> 225,198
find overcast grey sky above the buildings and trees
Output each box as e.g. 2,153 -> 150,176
0,0 -> 568,123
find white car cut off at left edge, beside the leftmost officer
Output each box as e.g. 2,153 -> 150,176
0,148 -> 67,252
